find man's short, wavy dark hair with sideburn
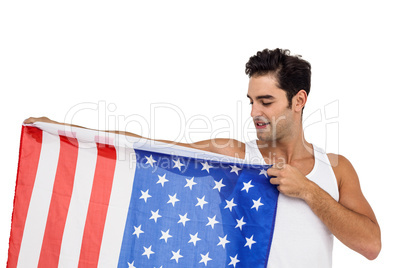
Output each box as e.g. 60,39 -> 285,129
246,48 -> 311,107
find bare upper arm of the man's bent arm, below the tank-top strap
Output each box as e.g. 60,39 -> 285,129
328,154 -> 377,223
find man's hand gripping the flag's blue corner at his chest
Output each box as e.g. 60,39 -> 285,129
267,164 -> 311,199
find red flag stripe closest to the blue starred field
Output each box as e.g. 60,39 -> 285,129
78,143 -> 116,268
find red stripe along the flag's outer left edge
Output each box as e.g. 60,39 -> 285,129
7,126 -> 42,268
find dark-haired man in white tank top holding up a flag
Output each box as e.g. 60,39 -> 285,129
25,49 -> 381,268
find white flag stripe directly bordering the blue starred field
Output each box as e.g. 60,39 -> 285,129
98,147 -> 136,268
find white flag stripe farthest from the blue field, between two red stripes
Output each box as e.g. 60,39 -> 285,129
17,131 -> 60,268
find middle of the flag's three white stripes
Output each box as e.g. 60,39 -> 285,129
59,142 -> 97,267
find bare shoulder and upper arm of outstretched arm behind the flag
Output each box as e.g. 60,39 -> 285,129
189,139 -> 246,159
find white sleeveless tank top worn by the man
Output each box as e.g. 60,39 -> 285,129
245,140 -> 339,268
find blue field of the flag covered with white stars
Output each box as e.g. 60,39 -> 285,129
119,150 -> 278,268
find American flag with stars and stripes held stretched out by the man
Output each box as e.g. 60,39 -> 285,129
7,123 -> 278,268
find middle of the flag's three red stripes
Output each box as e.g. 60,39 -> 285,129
38,136 -> 78,267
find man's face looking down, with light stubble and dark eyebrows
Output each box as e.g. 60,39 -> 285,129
247,74 -> 294,142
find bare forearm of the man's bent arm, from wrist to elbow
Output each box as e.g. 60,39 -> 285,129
303,182 -> 381,259
